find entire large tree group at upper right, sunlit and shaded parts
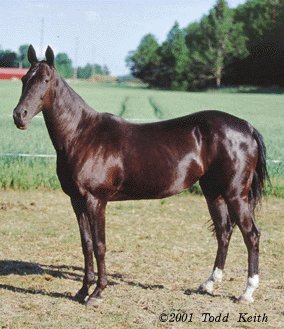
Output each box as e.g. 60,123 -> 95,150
126,0 -> 284,90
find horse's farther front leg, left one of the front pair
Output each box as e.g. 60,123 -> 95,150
71,198 -> 95,303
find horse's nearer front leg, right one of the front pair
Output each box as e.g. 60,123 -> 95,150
85,194 -> 107,307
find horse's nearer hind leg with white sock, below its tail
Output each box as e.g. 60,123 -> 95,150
227,197 -> 260,302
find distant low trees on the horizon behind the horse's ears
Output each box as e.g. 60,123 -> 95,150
0,45 -> 110,79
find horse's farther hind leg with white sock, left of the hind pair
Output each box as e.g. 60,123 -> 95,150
199,189 -> 233,294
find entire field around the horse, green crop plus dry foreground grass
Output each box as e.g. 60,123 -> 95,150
0,81 -> 284,329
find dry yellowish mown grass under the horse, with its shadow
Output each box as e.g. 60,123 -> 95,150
0,190 -> 284,329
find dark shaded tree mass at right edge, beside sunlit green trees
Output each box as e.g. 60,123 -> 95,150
225,0 -> 284,86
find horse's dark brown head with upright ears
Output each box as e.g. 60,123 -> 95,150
13,45 -> 55,129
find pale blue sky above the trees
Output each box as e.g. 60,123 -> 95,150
0,0 -> 246,76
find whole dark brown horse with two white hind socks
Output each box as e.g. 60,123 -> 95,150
14,46 -> 268,306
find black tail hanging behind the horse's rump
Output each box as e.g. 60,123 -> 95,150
249,128 -> 271,211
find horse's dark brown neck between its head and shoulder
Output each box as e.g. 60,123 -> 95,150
43,72 -> 97,152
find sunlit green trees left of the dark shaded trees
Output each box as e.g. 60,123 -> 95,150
127,0 -> 247,90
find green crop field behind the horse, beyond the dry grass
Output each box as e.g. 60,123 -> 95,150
0,81 -> 284,197
